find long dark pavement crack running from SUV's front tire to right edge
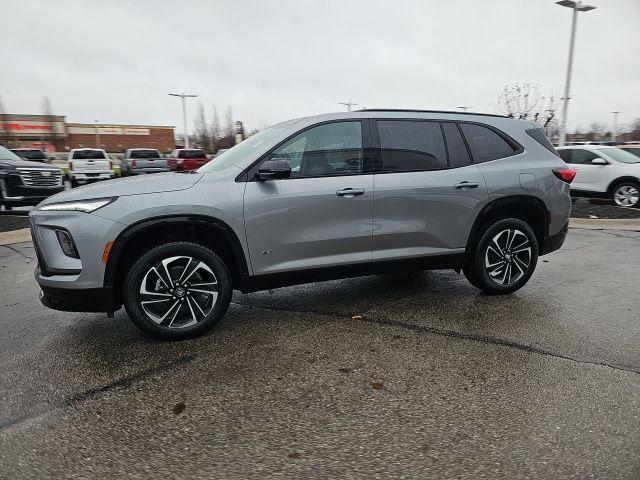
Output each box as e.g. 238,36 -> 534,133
231,302 -> 640,374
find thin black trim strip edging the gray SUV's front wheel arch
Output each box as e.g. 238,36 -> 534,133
104,214 -> 249,287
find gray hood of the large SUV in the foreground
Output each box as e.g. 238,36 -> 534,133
42,173 -> 202,205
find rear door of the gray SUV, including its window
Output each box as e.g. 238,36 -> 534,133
373,120 -> 487,260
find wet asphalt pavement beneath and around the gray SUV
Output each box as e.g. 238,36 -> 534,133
0,230 -> 640,479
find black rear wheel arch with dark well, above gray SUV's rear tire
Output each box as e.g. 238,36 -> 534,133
465,195 -> 549,255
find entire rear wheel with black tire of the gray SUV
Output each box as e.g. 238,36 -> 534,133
463,218 -> 538,295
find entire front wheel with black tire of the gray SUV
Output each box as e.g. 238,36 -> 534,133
122,242 -> 233,340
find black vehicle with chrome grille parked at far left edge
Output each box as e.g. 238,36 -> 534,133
0,146 -> 64,210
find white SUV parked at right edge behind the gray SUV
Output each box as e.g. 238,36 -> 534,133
558,145 -> 640,207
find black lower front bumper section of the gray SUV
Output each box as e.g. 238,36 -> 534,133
40,287 -> 120,312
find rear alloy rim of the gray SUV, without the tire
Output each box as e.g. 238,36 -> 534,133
484,228 -> 532,286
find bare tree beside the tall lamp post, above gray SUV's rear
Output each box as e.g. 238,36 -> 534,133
495,83 -> 560,135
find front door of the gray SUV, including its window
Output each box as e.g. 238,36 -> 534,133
244,121 -> 373,275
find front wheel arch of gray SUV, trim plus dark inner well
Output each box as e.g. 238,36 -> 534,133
104,215 -> 249,304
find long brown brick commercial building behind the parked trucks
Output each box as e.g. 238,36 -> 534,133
0,114 -> 175,153
